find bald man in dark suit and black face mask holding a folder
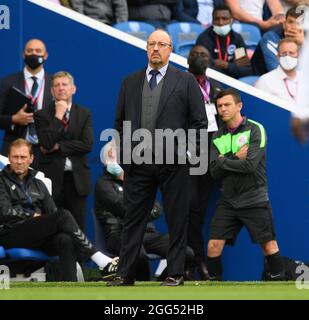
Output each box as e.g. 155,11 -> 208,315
0,39 -> 52,164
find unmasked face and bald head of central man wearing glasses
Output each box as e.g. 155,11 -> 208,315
147,30 -> 173,69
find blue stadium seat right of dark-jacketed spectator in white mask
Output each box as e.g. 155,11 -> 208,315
232,21 -> 261,50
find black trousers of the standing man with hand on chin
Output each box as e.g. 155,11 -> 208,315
54,171 -> 87,232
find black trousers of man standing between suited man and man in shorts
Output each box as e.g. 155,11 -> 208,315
188,171 -> 214,264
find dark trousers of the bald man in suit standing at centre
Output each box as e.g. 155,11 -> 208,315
117,164 -> 189,279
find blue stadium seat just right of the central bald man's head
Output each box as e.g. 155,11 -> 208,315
166,22 -> 205,55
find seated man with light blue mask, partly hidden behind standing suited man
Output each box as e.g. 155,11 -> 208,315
95,142 -> 194,281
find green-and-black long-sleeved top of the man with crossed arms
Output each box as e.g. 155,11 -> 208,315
210,117 -> 269,208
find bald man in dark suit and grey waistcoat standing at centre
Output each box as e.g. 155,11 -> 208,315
109,30 -> 207,286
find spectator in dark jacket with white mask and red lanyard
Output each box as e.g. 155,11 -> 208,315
196,5 -> 252,79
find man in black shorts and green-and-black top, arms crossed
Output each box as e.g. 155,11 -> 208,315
207,89 -> 285,280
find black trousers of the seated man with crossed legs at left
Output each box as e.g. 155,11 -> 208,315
0,210 -> 97,281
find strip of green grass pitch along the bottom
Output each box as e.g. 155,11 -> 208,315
0,281 -> 309,300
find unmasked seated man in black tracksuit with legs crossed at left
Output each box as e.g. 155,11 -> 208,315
0,139 -> 118,281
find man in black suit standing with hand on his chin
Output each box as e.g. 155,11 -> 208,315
35,71 -> 93,231
